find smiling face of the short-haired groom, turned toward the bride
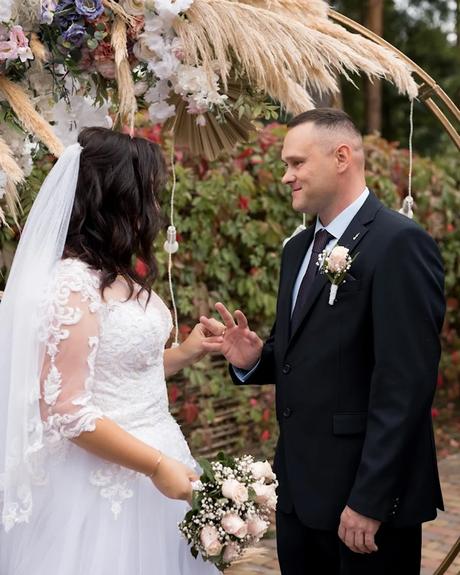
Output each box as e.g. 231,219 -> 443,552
281,122 -> 337,214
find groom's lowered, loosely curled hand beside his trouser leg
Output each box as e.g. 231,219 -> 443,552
339,505 -> 381,553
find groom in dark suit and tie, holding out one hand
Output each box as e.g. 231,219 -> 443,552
201,108 -> 444,575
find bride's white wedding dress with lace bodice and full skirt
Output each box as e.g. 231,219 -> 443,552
0,259 -> 217,575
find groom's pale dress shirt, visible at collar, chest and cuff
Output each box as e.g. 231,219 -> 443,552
233,187 -> 369,382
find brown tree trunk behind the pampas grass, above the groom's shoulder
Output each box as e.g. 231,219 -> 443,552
365,0 -> 382,134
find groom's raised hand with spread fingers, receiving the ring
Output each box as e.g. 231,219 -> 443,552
200,302 -> 263,370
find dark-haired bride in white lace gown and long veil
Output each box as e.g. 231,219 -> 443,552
0,128 -> 217,575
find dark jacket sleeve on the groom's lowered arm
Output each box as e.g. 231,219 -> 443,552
348,226 -> 445,521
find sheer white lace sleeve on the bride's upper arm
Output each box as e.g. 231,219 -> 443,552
40,262 -> 103,439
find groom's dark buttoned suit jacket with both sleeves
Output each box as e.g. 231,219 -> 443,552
231,193 -> 445,529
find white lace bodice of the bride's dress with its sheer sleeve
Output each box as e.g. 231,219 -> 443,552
40,259 -> 194,515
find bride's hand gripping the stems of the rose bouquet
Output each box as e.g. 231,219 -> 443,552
151,455 -> 199,503
